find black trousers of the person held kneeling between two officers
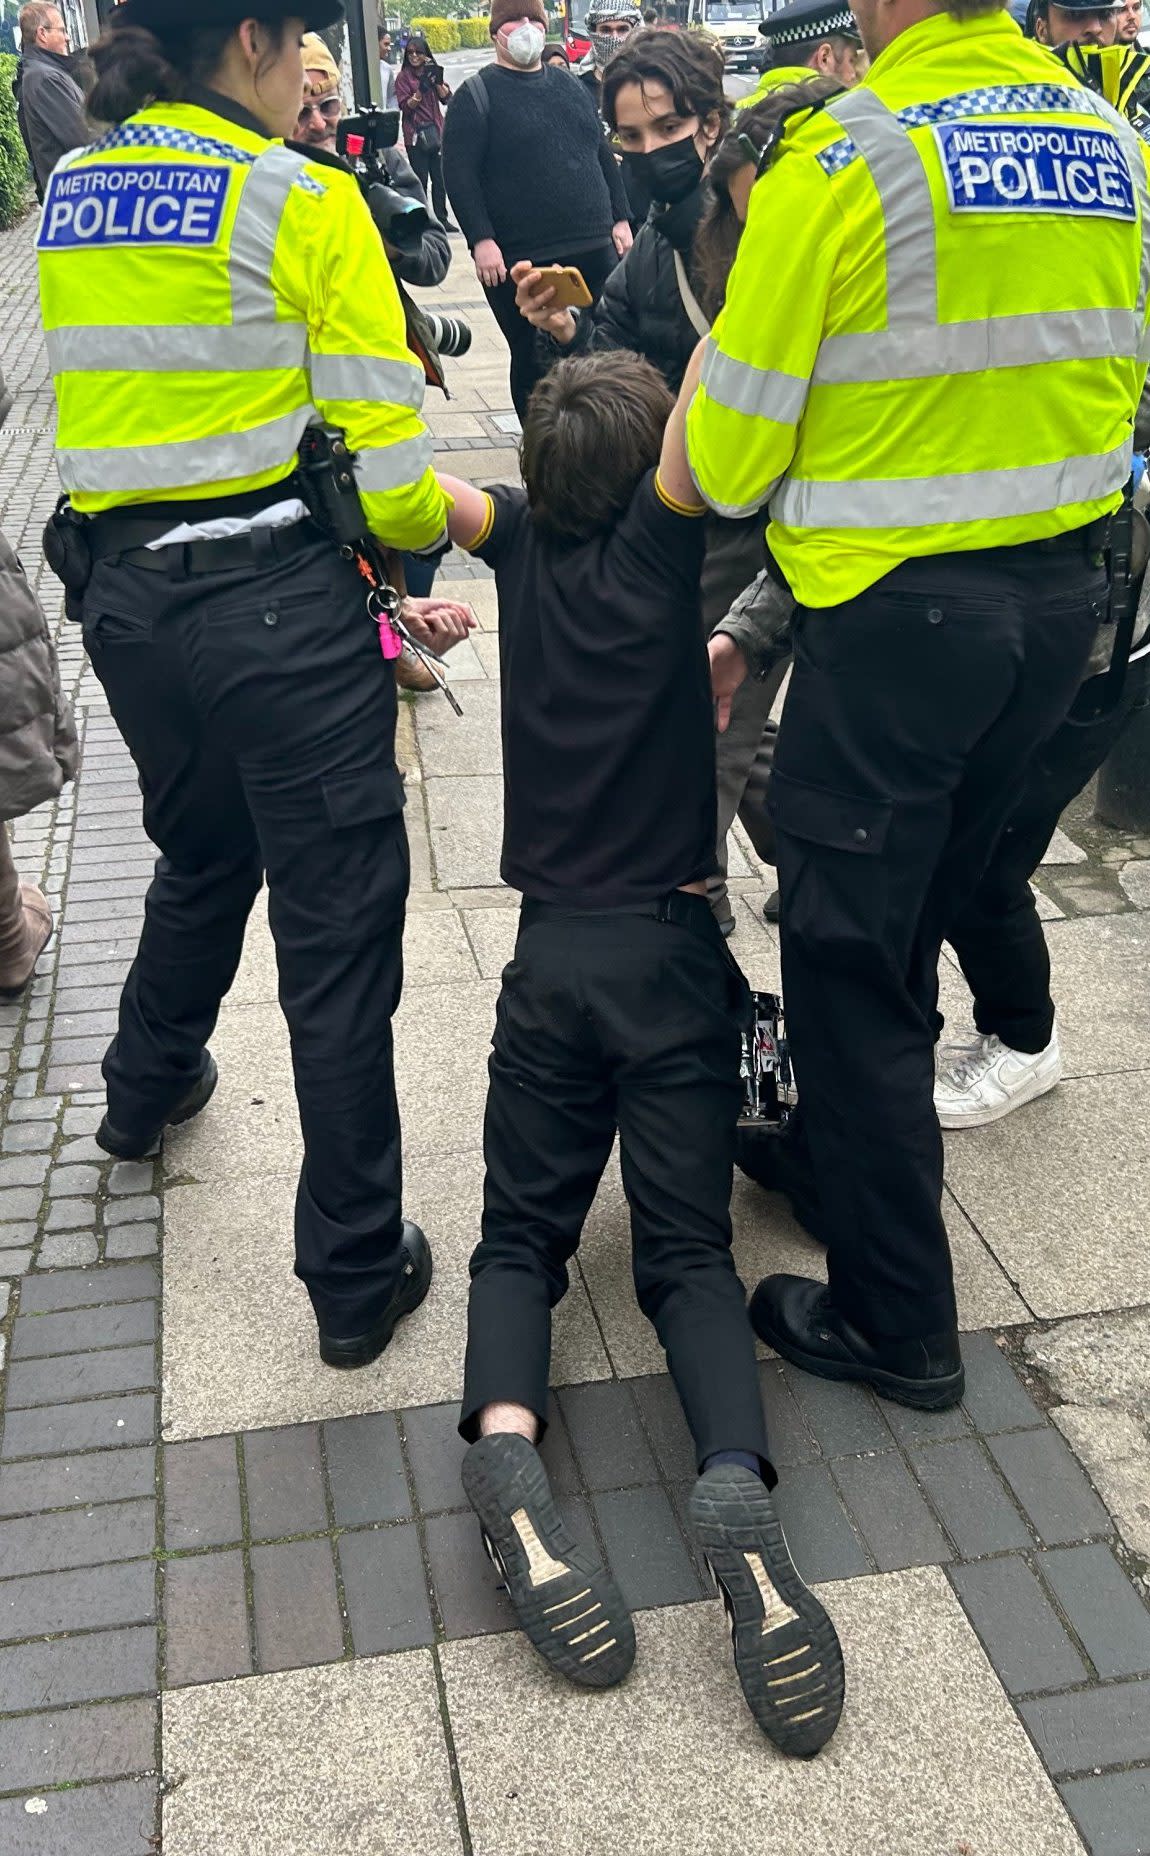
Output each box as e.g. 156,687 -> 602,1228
460,893 -> 773,1474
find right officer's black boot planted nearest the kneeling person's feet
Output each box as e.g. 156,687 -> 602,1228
749,1275 -> 966,1411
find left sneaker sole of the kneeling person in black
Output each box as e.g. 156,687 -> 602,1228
462,1433 -> 634,1689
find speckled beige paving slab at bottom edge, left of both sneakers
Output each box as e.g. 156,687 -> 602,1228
163,1650 -> 462,1856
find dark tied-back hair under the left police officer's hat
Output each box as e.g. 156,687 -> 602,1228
87,7 -> 288,122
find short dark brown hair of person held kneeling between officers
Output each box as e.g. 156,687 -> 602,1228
519,349 -> 675,542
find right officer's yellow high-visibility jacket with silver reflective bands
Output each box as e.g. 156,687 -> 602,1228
686,13 -> 1150,607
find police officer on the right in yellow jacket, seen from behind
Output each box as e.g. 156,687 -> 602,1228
688,0 -> 1150,1407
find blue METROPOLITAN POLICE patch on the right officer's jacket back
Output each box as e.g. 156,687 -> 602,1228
933,122 -> 1137,219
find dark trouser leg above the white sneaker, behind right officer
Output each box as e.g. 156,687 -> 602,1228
946,666 -> 1144,1052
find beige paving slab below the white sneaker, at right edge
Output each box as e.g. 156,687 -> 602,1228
946,1073 -> 1150,1318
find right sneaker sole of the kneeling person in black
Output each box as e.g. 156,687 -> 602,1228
690,1464 -> 846,1759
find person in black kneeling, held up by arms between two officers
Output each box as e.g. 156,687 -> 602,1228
443,353 -> 844,1756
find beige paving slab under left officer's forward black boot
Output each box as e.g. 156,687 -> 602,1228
163,1151 -> 610,1442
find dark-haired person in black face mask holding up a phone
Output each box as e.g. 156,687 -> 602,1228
512,32 -> 790,934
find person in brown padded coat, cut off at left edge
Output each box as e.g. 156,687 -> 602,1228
0,361 -> 78,1004
